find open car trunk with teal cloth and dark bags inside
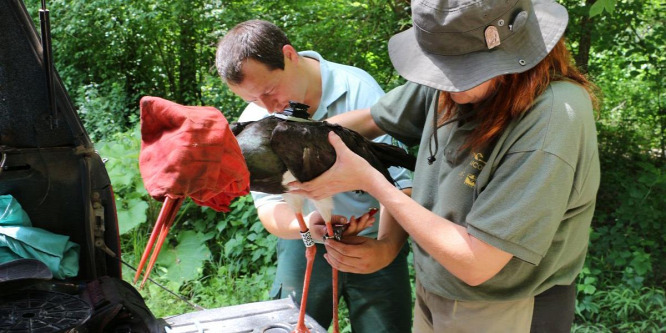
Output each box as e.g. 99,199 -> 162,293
0,0 -> 326,333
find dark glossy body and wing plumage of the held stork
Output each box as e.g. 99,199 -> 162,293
231,116 -> 416,194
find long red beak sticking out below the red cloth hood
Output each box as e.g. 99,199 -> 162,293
134,196 -> 185,289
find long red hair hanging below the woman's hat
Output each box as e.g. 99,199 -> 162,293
438,37 -> 598,149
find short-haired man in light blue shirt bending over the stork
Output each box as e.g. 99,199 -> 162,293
216,20 -> 412,332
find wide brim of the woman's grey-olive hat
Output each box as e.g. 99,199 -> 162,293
388,1 -> 569,92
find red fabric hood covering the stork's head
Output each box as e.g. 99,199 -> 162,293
139,96 -> 250,212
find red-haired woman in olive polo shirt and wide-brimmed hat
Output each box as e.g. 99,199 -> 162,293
291,0 -> 599,332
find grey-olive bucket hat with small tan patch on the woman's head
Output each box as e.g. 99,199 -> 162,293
389,0 -> 569,92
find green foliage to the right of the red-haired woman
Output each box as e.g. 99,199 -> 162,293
566,0 -> 666,326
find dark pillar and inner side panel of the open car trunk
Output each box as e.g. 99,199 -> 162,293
0,0 -> 120,280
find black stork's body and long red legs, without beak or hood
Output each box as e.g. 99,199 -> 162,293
231,103 -> 416,333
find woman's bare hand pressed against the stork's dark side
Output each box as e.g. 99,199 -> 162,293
287,132 -> 385,200
